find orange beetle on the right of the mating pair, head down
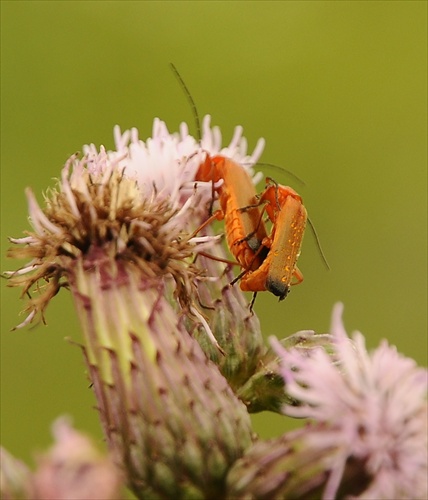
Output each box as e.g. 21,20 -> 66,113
240,178 -> 308,300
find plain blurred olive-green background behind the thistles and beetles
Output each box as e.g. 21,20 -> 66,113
1,1 -> 427,472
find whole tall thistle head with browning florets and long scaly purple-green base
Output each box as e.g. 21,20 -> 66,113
3,118 -> 262,498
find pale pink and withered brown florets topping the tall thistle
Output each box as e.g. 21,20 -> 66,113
5,116 -> 264,334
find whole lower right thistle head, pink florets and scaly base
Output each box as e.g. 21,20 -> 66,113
228,304 -> 428,500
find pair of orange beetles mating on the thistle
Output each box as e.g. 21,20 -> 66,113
195,154 -> 307,305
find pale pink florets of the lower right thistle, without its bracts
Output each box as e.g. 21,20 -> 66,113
272,304 -> 428,499
